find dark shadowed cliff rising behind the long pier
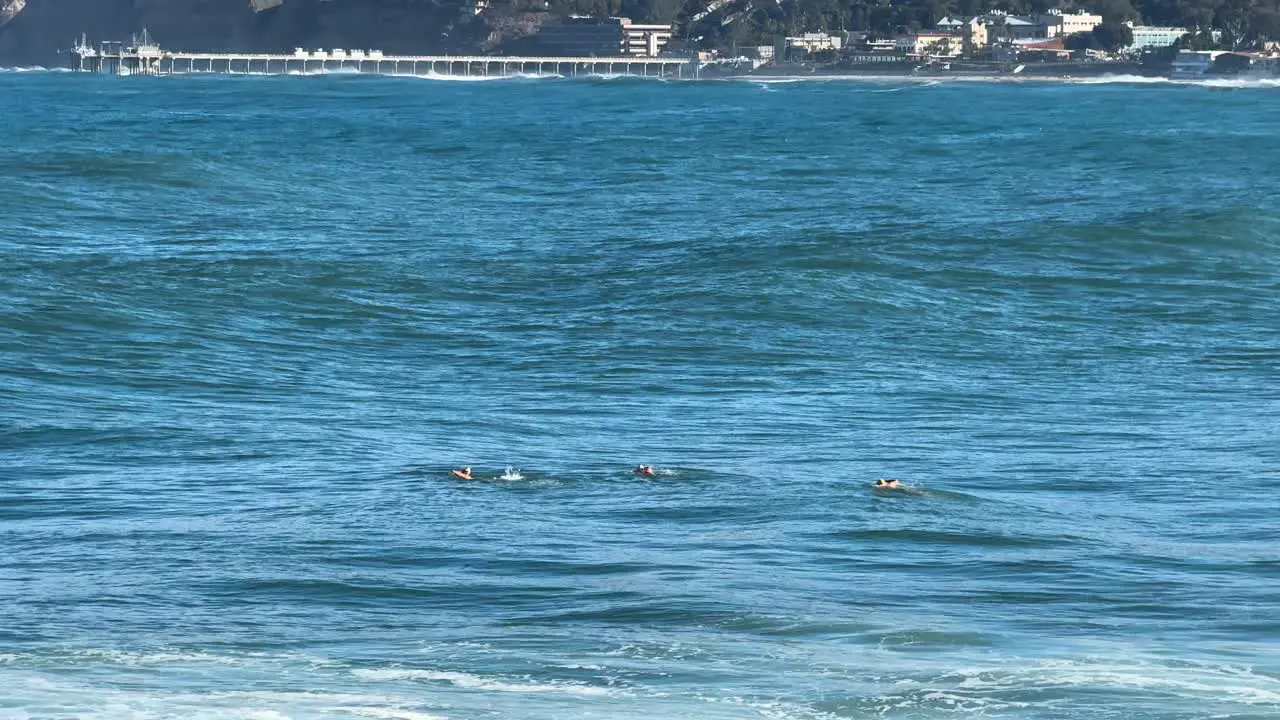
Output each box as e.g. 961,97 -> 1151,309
0,0 -> 492,65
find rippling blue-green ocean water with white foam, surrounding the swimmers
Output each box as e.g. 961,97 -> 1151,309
0,72 -> 1280,720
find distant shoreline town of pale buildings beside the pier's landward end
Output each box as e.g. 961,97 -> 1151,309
517,10 -> 1280,78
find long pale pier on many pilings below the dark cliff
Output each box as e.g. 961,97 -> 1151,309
72,32 -> 700,79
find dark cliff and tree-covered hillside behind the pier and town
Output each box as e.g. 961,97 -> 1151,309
0,0 -> 1280,65
